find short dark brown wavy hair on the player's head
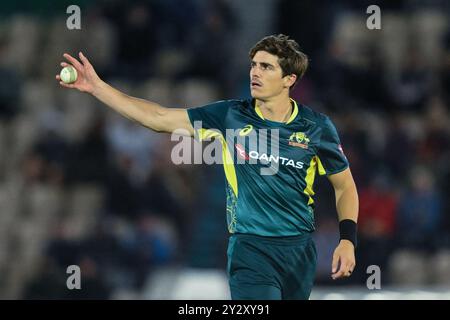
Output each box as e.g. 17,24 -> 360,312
249,34 -> 308,87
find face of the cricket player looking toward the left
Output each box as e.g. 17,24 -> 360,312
250,51 -> 292,100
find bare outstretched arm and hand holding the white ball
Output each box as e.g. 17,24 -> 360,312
56,52 -> 194,136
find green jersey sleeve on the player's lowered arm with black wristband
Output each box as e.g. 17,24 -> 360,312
317,117 -> 349,175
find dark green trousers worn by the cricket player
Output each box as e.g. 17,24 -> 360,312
227,234 -> 317,300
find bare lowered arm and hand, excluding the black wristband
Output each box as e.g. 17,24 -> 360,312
328,168 -> 359,279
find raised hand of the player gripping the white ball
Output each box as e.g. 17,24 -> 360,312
56,52 -> 101,93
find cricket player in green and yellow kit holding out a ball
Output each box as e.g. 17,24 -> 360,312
56,35 -> 358,299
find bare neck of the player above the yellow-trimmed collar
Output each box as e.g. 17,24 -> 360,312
255,96 -> 293,122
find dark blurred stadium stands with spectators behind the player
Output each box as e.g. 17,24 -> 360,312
0,0 -> 450,299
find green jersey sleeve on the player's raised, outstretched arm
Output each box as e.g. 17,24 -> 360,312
187,101 -> 230,140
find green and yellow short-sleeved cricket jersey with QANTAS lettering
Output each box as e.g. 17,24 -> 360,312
188,99 -> 349,237
